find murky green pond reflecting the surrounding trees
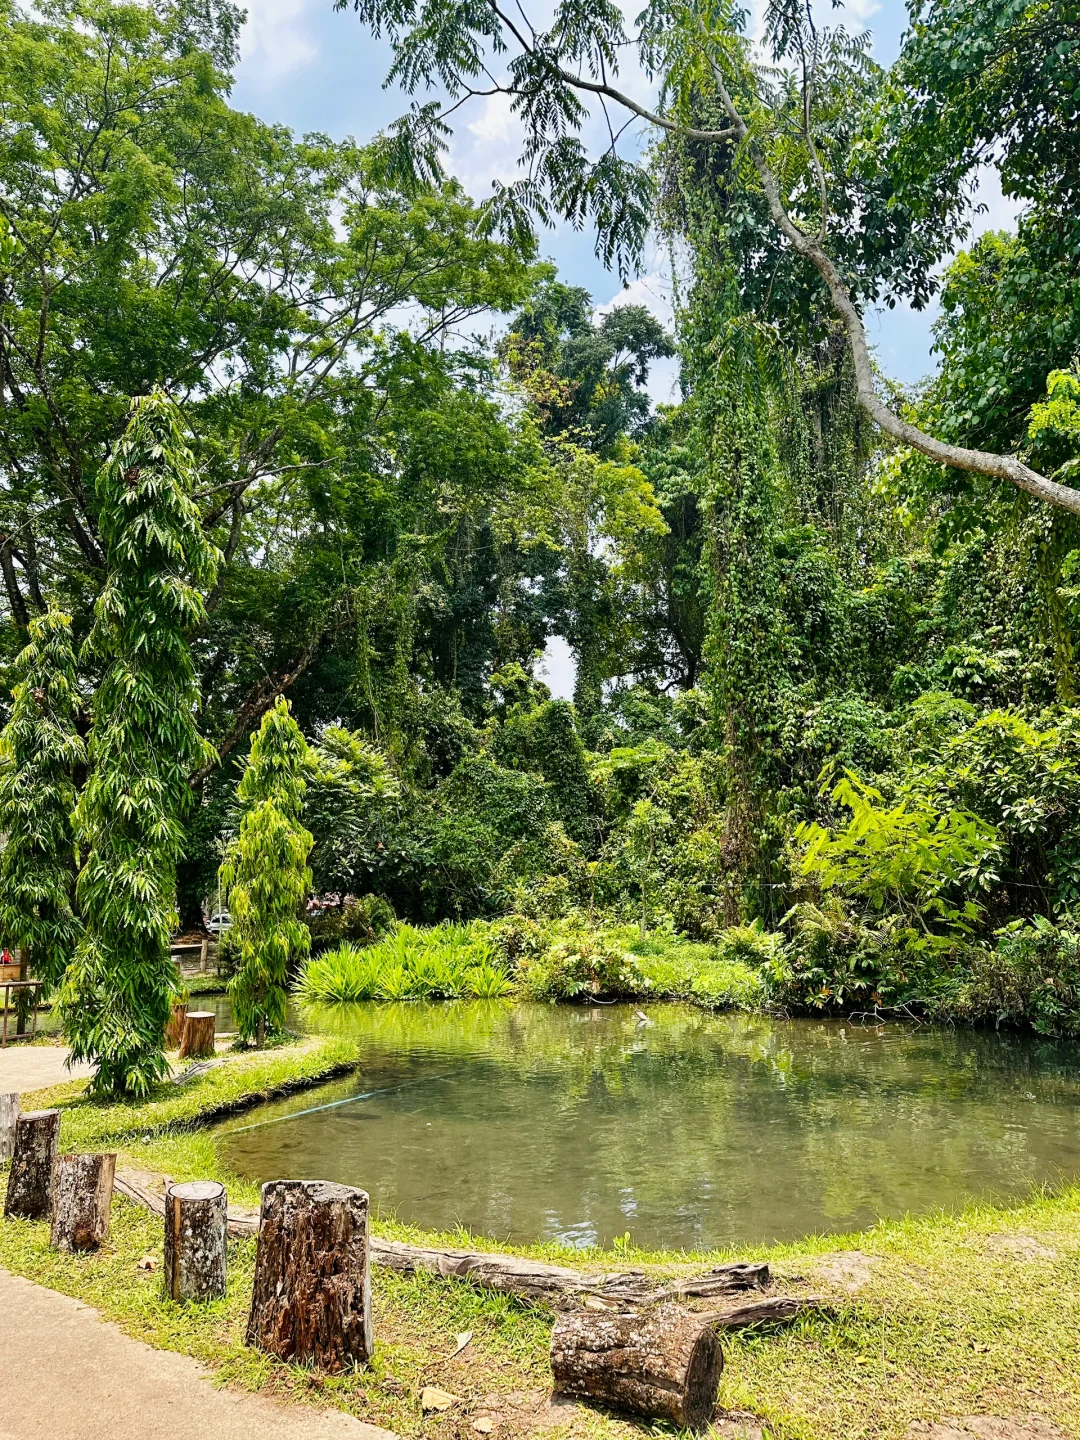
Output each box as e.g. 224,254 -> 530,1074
222,1002 -> 1080,1248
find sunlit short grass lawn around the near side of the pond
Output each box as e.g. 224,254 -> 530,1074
0,1040 -> 1080,1440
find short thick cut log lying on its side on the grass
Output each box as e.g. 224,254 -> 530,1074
552,1305 -> 724,1430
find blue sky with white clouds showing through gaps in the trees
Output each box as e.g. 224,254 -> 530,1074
233,0 -> 1012,694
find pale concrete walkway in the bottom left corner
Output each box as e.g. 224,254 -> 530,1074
0,1270 -> 396,1440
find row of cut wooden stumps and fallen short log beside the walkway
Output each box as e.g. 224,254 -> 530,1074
0,1096 -> 723,1430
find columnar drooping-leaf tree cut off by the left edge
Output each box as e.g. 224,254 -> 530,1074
0,609 -> 85,989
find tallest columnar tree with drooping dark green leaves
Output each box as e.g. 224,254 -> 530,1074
59,392 -> 219,1096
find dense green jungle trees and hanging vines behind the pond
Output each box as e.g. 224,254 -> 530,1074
0,0 -> 1080,1077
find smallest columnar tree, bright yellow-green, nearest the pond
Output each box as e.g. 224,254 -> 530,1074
220,696 -> 312,1044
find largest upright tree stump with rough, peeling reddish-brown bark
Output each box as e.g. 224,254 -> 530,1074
248,1179 -> 374,1372
